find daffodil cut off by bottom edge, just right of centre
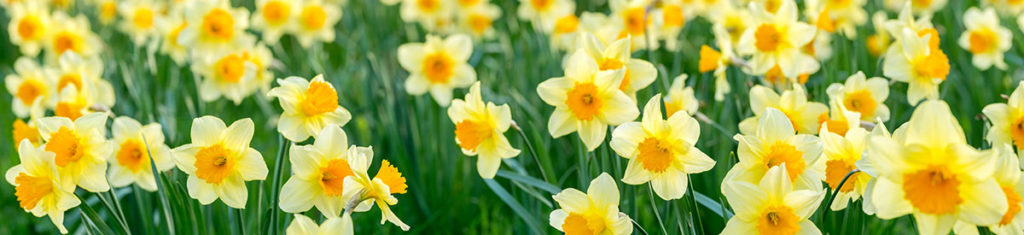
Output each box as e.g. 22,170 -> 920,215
549,172 -> 633,235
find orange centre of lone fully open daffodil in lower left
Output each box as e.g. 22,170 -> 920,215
195,144 -> 237,184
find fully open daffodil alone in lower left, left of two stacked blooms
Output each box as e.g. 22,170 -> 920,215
171,116 -> 267,208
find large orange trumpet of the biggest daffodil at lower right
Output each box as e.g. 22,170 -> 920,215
903,165 -> 964,214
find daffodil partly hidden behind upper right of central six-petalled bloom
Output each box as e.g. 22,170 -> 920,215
577,34 -> 657,100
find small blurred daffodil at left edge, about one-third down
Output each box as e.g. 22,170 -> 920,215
4,57 -> 57,118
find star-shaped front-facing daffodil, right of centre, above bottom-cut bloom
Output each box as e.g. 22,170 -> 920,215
608,94 -> 715,200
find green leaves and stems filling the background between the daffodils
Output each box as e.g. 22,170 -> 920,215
0,0 -> 1024,234
